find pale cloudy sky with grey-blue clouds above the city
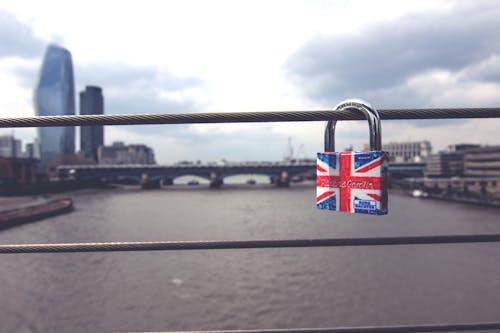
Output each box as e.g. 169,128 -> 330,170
0,0 -> 500,164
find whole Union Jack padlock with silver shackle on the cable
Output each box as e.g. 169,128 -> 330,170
316,99 -> 389,215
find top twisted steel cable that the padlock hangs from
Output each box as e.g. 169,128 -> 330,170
0,108 -> 500,128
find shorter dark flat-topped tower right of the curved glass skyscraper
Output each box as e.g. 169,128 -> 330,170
80,86 -> 104,161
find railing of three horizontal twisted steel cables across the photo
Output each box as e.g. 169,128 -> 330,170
0,108 -> 500,333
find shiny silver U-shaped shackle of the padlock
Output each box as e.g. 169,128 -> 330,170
325,99 -> 382,152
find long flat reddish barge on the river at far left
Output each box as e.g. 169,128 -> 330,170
0,198 -> 73,229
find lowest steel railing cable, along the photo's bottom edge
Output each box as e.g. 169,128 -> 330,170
114,323 -> 500,333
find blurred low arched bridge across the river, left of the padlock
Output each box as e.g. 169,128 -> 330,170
57,161 -> 316,188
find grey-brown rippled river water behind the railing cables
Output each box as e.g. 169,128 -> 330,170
0,185 -> 500,333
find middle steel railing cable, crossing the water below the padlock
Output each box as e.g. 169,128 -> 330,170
0,234 -> 500,254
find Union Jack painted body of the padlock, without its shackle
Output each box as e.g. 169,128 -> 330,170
316,151 -> 389,215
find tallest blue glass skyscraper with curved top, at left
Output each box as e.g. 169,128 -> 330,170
35,45 -> 75,169
